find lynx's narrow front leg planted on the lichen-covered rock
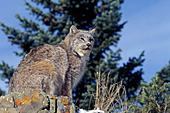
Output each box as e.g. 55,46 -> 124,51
62,75 -> 72,99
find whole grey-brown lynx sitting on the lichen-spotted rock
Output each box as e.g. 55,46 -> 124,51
8,25 -> 95,98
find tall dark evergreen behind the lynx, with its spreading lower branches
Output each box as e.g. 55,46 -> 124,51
0,0 -> 144,108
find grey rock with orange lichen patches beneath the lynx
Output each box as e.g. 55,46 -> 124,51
0,90 -> 75,113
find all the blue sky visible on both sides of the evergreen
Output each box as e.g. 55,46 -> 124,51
0,0 -> 170,91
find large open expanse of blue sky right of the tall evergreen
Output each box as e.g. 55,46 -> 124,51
119,0 -> 170,82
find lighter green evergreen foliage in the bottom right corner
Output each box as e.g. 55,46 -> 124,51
129,75 -> 170,113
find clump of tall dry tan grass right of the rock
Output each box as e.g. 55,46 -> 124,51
93,70 -> 127,113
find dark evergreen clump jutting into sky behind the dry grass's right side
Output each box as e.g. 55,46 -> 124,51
118,51 -> 144,99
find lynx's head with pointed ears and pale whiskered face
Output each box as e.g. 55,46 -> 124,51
65,25 -> 95,59
